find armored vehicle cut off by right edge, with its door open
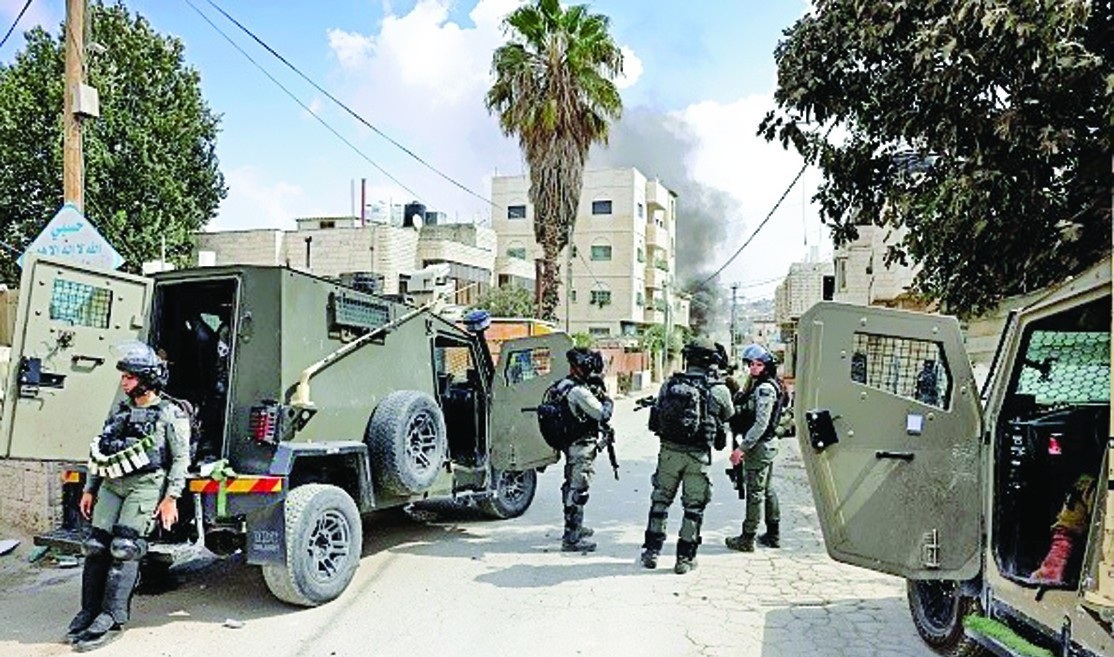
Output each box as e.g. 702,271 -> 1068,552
795,258 -> 1114,657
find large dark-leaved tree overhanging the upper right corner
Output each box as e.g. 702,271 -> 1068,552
760,0 -> 1114,314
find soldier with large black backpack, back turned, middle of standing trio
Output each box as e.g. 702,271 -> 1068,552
642,339 -> 735,575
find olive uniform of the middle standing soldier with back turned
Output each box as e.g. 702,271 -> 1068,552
642,363 -> 735,573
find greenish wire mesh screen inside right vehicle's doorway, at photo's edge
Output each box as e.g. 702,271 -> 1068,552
1017,331 -> 1111,405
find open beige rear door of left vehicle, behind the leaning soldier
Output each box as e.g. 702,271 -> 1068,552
0,254 -> 153,461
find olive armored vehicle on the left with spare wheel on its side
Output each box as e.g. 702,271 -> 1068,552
0,257 -> 571,606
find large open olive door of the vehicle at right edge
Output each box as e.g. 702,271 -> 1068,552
795,302 -> 983,579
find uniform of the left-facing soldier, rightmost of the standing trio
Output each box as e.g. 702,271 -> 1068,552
727,376 -> 781,551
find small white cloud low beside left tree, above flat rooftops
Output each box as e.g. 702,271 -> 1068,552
206,166 -> 303,232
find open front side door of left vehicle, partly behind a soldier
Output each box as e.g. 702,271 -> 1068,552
491,333 -> 573,471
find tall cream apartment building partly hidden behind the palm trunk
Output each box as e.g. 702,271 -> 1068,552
491,168 -> 690,337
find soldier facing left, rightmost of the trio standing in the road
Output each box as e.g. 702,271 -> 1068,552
725,344 -> 782,552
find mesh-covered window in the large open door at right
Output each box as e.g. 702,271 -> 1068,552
851,333 -> 952,409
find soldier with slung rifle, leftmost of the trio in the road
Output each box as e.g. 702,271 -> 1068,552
557,347 -> 614,552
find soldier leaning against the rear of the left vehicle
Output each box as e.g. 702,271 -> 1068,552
67,343 -> 189,651
